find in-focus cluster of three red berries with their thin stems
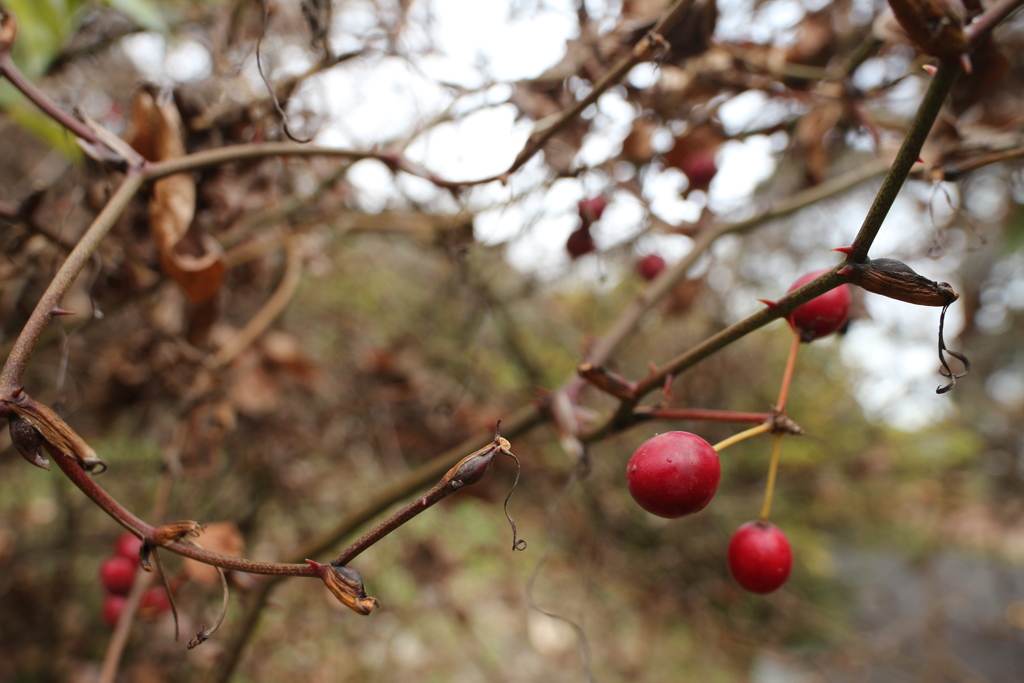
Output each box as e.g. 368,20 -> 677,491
626,270 -> 850,593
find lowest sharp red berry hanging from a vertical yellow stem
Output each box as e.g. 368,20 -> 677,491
728,521 -> 793,593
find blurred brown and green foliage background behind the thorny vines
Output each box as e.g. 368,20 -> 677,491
0,0 -> 1024,683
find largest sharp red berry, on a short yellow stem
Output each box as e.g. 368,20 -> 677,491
626,432 -> 722,519
